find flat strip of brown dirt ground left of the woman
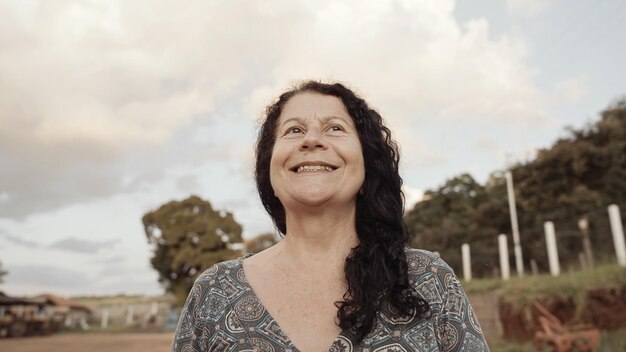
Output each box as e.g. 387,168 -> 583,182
0,332 -> 174,352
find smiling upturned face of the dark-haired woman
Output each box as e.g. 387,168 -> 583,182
270,92 -> 365,211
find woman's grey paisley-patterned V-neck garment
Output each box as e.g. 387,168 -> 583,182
172,249 -> 489,352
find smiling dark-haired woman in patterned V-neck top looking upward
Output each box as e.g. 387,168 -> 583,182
172,81 -> 488,352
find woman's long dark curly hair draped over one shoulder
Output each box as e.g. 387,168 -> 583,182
255,81 -> 429,343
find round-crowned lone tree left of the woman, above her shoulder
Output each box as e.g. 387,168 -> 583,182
142,196 -> 243,303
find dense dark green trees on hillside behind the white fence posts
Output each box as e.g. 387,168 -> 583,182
405,99 -> 626,277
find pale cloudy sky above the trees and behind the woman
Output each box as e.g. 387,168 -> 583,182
0,0 -> 626,296
